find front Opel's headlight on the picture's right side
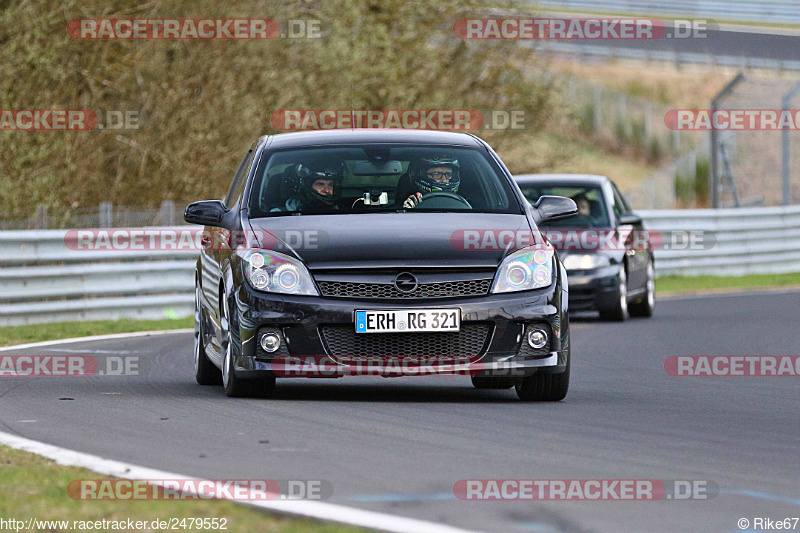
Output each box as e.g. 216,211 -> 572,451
492,246 -> 554,293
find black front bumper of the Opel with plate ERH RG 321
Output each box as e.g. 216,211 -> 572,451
225,283 -> 569,378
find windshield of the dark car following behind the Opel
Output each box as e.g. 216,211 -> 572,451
520,184 -> 610,228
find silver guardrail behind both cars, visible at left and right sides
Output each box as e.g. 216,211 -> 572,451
0,206 -> 800,326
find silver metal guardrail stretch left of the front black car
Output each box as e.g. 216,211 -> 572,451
0,230 -> 197,326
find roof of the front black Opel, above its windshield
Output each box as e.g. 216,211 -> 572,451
269,128 -> 483,150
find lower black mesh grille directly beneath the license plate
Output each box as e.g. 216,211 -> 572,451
320,323 -> 492,359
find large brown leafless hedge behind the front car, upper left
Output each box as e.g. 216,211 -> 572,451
0,0 -> 555,218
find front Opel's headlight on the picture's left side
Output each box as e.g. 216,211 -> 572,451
239,250 -> 319,296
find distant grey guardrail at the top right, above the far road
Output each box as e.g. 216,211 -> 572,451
536,0 -> 800,24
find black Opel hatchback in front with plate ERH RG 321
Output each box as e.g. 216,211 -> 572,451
184,129 -> 577,400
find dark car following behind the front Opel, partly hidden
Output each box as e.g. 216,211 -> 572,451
514,174 -> 656,320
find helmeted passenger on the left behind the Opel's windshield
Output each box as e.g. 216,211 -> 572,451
272,162 -> 344,212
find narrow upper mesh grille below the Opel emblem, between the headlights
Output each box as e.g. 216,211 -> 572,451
317,279 -> 492,299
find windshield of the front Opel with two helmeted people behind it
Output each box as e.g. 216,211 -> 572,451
250,144 -> 523,218
